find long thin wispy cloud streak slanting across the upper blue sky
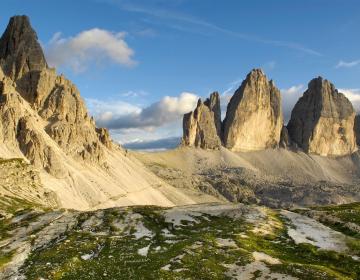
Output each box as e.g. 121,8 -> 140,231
98,0 -> 322,56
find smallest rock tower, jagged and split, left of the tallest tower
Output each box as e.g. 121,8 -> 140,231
182,93 -> 221,149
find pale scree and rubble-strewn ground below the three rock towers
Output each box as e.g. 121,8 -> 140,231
135,148 -> 360,208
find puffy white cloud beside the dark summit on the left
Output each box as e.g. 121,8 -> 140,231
45,28 -> 136,72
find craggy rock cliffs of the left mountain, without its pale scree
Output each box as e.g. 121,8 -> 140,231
0,16 -> 111,174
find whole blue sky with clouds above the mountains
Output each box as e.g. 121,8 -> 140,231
0,0 -> 360,149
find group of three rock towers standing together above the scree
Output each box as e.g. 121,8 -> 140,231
182,69 -> 360,156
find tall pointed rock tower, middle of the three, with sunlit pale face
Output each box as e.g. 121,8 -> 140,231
223,69 -> 283,151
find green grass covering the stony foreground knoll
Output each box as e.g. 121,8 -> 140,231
14,207 -> 360,280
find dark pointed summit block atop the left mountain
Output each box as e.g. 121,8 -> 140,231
0,16 -> 47,80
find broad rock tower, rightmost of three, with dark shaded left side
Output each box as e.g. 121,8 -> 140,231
287,77 -> 356,156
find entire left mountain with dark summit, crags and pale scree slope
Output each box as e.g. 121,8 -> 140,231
0,16 -> 194,210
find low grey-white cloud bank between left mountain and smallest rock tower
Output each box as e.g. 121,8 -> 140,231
87,92 -> 198,131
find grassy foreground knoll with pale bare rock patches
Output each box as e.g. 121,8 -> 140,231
0,203 -> 360,279
